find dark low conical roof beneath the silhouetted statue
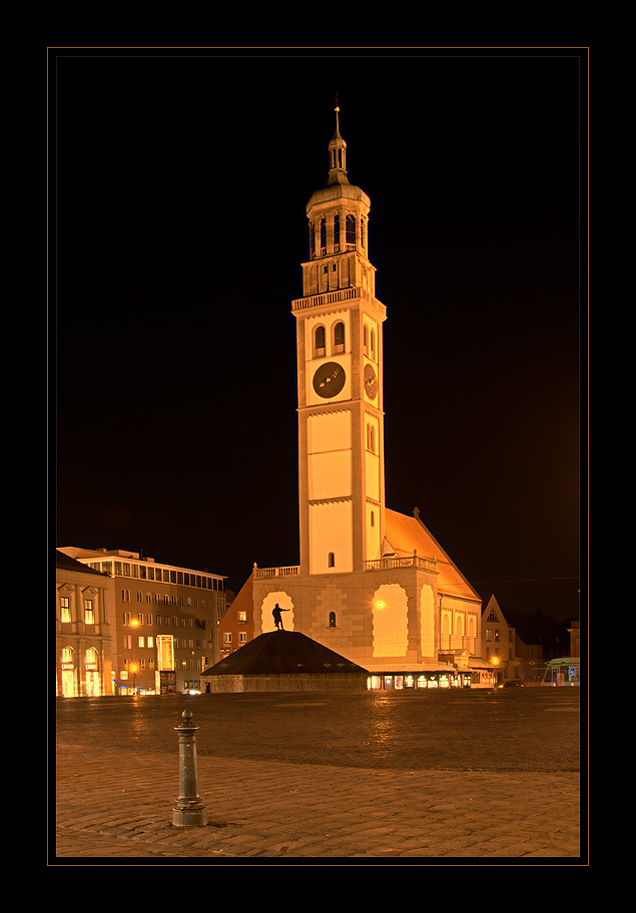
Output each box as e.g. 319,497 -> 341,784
201,631 -> 366,675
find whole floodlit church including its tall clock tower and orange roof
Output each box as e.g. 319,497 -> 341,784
250,108 -> 481,675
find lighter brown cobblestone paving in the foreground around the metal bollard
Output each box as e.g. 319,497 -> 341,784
49,698 -> 584,865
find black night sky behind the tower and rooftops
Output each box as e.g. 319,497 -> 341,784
49,48 -> 587,618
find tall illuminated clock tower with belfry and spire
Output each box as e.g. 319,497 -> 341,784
292,108 -> 386,576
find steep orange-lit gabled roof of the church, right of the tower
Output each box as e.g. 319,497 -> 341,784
385,507 -> 481,602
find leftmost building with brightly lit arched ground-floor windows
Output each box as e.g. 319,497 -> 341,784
55,551 -> 115,697
